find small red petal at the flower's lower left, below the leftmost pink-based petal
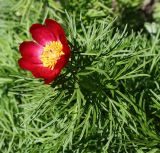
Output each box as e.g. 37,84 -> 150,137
18,58 -> 39,71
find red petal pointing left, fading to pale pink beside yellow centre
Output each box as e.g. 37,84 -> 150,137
19,41 -> 43,58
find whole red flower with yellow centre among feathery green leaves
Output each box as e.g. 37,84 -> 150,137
18,19 -> 70,83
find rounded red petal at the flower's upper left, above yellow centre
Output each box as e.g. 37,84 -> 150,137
30,24 -> 55,46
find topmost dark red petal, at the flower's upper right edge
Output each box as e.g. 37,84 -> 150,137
45,19 -> 66,40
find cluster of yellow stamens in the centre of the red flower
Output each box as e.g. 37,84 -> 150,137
40,41 -> 64,70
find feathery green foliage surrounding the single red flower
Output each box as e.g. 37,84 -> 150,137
0,0 -> 160,153
